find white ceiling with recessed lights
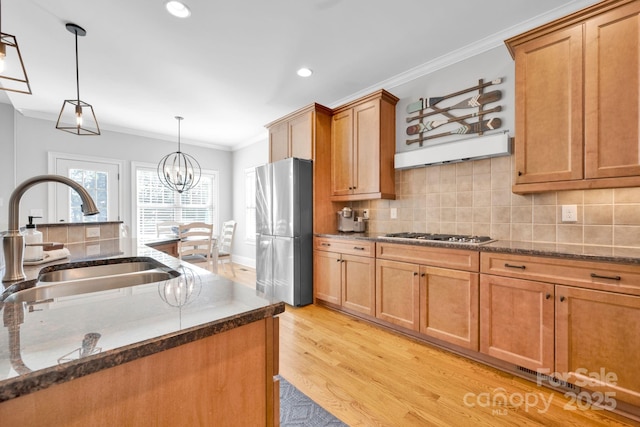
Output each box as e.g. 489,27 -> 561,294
0,0 -> 597,150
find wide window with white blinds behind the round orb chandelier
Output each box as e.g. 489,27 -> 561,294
134,165 -> 218,238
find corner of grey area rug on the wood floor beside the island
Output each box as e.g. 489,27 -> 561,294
279,377 -> 347,427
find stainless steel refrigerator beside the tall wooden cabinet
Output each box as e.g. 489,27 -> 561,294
256,158 -> 313,306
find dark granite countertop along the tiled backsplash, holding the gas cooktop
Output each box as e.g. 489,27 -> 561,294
315,232 -> 640,265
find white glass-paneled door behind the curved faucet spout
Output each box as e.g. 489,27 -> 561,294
55,158 -> 120,222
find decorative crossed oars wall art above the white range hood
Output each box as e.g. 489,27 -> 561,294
407,79 -> 502,147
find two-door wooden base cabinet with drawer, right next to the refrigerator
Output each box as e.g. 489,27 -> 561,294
313,237 -> 375,316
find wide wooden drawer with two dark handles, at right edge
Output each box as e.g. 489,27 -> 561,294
480,252 -> 640,295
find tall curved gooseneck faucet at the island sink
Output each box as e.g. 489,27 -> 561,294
2,175 -> 100,282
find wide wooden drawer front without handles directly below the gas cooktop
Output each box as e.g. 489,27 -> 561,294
376,242 -> 480,271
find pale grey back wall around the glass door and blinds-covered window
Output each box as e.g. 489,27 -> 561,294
0,110 -> 233,236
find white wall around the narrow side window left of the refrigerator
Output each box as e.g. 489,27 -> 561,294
233,139 -> 269,267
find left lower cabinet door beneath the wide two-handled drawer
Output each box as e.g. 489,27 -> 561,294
480,274 -> 554,372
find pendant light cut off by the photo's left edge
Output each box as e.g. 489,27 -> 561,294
0,1 -> 31,95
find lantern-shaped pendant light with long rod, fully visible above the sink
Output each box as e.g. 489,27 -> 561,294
56,23 -> 100,135
